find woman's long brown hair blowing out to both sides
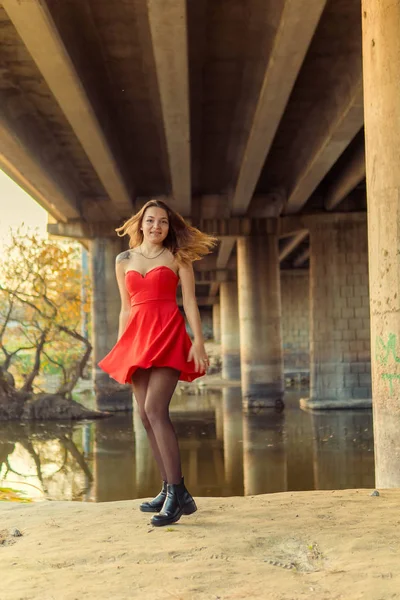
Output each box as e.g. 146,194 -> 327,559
115,200 -> 218,263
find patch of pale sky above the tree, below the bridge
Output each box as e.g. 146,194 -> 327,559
0,170 -> 47,257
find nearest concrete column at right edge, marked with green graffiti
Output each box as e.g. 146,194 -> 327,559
362,0 -> 400,488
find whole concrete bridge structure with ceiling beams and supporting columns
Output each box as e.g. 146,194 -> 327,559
0,0 -> 400,483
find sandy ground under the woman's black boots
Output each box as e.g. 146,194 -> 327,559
0,490 -> 400,600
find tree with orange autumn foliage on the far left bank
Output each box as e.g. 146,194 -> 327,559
0,231 -> 100,418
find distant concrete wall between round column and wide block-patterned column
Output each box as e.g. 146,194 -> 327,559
281,270 -> 310,373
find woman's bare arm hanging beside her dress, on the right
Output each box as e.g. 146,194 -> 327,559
179,264 -> 208,371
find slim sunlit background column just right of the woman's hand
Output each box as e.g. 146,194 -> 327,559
219,281 -> 240,379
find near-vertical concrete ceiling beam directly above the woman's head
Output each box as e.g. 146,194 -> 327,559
147,0 -> 191,216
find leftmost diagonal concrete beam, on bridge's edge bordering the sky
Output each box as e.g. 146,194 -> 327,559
0,115 -> 80,221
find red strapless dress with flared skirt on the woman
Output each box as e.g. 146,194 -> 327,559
99,265 -> 204,383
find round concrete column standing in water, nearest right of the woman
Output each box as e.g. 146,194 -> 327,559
237,234 -> 284,407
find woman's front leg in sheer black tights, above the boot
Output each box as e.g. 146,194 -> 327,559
144,367 -> 182,484
